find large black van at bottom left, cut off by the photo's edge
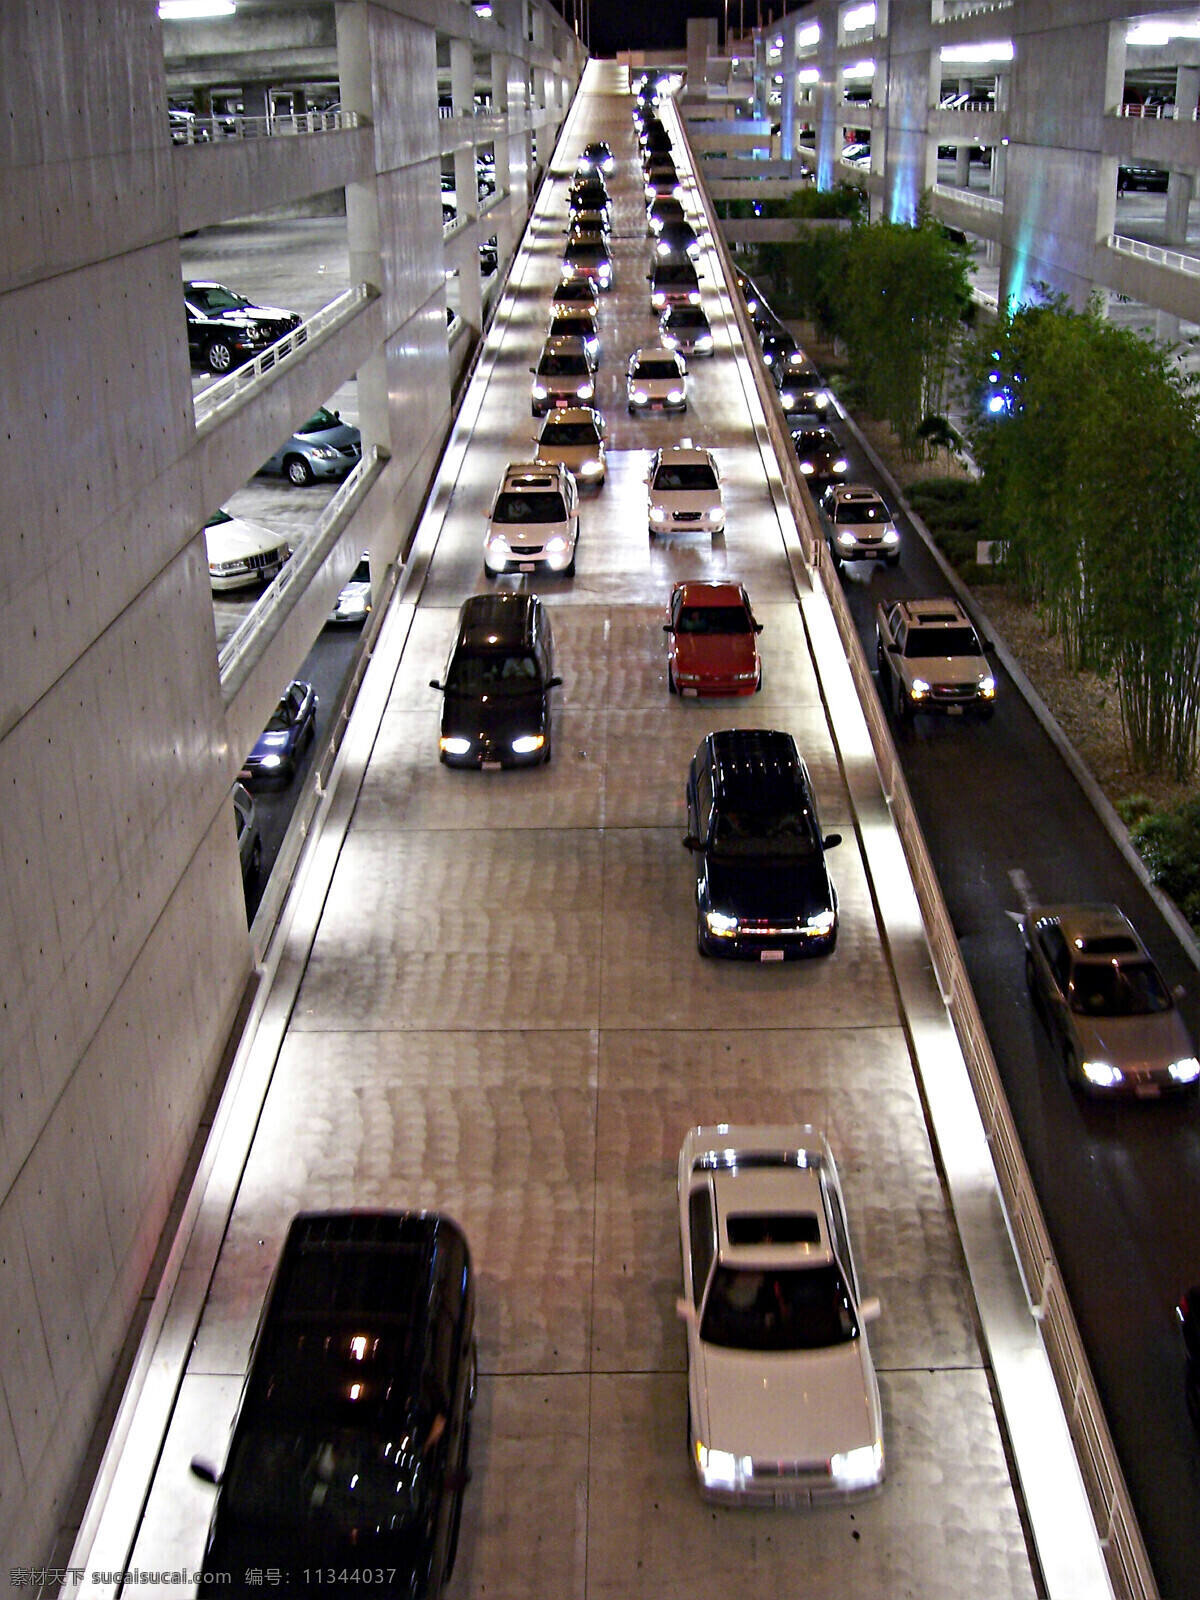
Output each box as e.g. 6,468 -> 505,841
192,1211 -> 477,1600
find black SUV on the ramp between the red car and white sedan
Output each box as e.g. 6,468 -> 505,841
683,728 -> 842,962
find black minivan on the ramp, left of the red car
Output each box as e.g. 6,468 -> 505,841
429,589 -> 562,771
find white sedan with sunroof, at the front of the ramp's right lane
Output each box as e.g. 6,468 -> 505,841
677,1123 -> 883,1506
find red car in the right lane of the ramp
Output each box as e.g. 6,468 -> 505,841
662,579 -> 763,696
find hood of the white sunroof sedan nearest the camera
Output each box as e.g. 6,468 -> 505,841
698,1339 -> 880,1466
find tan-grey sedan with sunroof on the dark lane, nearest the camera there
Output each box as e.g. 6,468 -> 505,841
1021,904 -> 1200,1099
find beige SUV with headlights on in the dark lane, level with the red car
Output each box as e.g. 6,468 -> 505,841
875,598 -> 995,720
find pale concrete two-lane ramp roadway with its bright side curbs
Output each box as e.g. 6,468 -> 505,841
51,56 -> 1106,1595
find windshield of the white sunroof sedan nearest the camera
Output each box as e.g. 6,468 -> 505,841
701,1262 -> 858,1350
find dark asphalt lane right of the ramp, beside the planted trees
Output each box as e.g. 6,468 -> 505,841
825,419 -> 1200,1595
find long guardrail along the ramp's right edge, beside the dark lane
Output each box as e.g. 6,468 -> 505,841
693,103 -> 1164,1600
